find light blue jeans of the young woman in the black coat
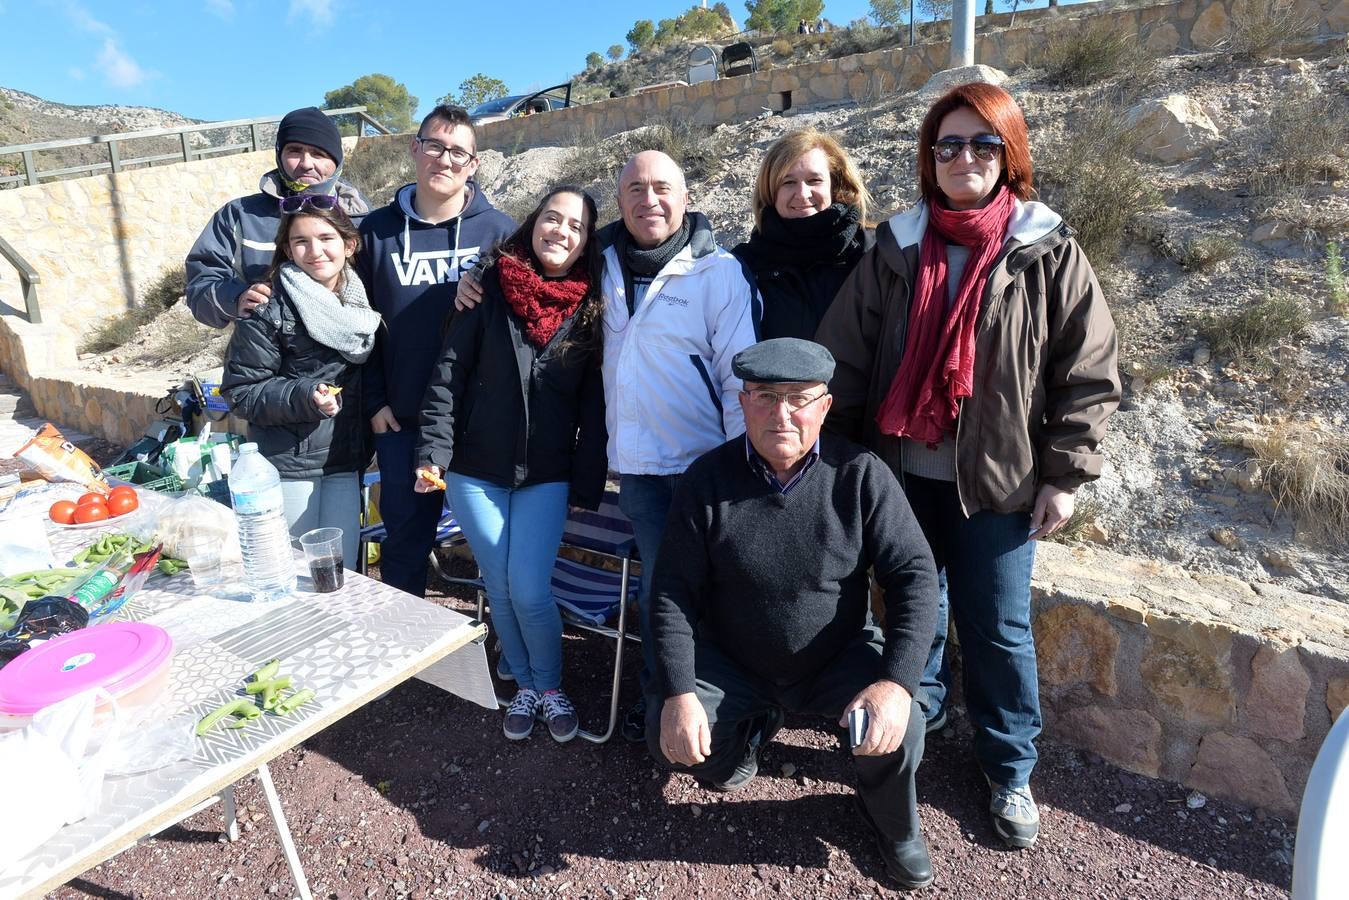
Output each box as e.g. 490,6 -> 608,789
445,472 -> 569,692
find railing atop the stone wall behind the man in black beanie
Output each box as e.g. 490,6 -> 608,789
0,107 -> 393,188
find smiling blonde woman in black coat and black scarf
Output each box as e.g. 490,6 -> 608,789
731,128 -> 871,340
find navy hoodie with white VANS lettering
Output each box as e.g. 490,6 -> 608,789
356,182 -> 515,428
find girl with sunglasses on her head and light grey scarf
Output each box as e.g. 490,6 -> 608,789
220,194 -> 380,568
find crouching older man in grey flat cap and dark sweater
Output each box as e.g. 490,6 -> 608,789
646,337 -> 938,888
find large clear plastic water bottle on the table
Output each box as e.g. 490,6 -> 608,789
229,444 -> 295,600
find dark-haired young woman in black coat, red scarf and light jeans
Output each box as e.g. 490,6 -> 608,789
415,188 -> 607,742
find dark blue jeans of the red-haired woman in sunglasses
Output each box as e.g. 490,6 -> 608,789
904,475 -> 1041,787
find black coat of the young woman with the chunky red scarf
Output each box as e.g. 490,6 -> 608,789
417,266 -> 608,509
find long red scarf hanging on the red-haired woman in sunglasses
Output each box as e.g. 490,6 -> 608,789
876,185 -> 1016,447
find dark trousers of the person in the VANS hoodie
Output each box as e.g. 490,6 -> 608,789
375,425 -> 445,596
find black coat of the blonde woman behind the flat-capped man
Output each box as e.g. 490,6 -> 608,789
731,209 -> 876,340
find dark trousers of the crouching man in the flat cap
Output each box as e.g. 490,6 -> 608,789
646,627 -> 924,841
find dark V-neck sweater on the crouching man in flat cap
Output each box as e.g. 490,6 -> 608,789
650,434 -> 938,699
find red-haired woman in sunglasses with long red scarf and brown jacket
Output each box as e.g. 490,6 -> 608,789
816,84 -> 1120,847
